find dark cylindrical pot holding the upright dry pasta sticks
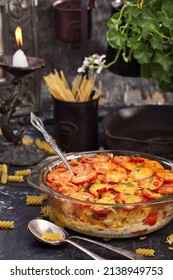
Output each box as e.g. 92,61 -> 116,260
53,98 -> 98,152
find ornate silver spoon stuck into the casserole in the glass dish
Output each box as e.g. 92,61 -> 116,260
30,112 -> 74,175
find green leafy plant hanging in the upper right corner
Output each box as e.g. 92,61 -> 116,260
79,0 -> 173,91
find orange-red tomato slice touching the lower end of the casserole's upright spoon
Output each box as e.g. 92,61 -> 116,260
72,163 -> 97,185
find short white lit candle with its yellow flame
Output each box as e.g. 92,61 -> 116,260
12,26 -> 28,67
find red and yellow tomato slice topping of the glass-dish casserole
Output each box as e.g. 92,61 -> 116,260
46,153 -> 173,212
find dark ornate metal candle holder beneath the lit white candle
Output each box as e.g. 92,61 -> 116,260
0,55 -> 45,166
